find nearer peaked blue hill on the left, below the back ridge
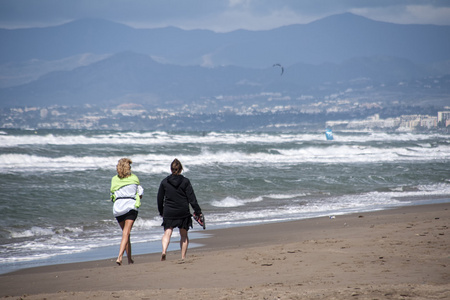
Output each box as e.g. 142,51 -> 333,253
0,52 -> 256,106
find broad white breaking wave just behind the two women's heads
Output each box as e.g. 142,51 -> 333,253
0,145 -> 450,174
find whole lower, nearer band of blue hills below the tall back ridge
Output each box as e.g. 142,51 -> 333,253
0,52 -> 442,107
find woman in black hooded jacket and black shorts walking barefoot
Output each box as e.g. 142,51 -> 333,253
158,159 -> 202,260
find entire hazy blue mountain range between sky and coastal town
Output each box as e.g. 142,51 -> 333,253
0,13 -> 450,107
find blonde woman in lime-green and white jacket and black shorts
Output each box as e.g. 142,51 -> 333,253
110,158 -> 144,266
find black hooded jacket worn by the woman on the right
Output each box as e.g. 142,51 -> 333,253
158,175 -> 202,219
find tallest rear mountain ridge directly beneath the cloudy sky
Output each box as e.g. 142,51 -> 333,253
0,13 -> 450,68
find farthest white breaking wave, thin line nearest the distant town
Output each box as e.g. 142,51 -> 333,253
0,131 -> 448,148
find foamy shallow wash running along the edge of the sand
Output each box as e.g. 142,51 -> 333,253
0,182 -> 450,267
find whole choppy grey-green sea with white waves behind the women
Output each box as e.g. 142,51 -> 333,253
0,130 -> 450,274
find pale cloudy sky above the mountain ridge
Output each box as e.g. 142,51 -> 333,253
0,0 -> 450,32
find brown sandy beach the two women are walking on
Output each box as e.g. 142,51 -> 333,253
0,203 -> 450,300
